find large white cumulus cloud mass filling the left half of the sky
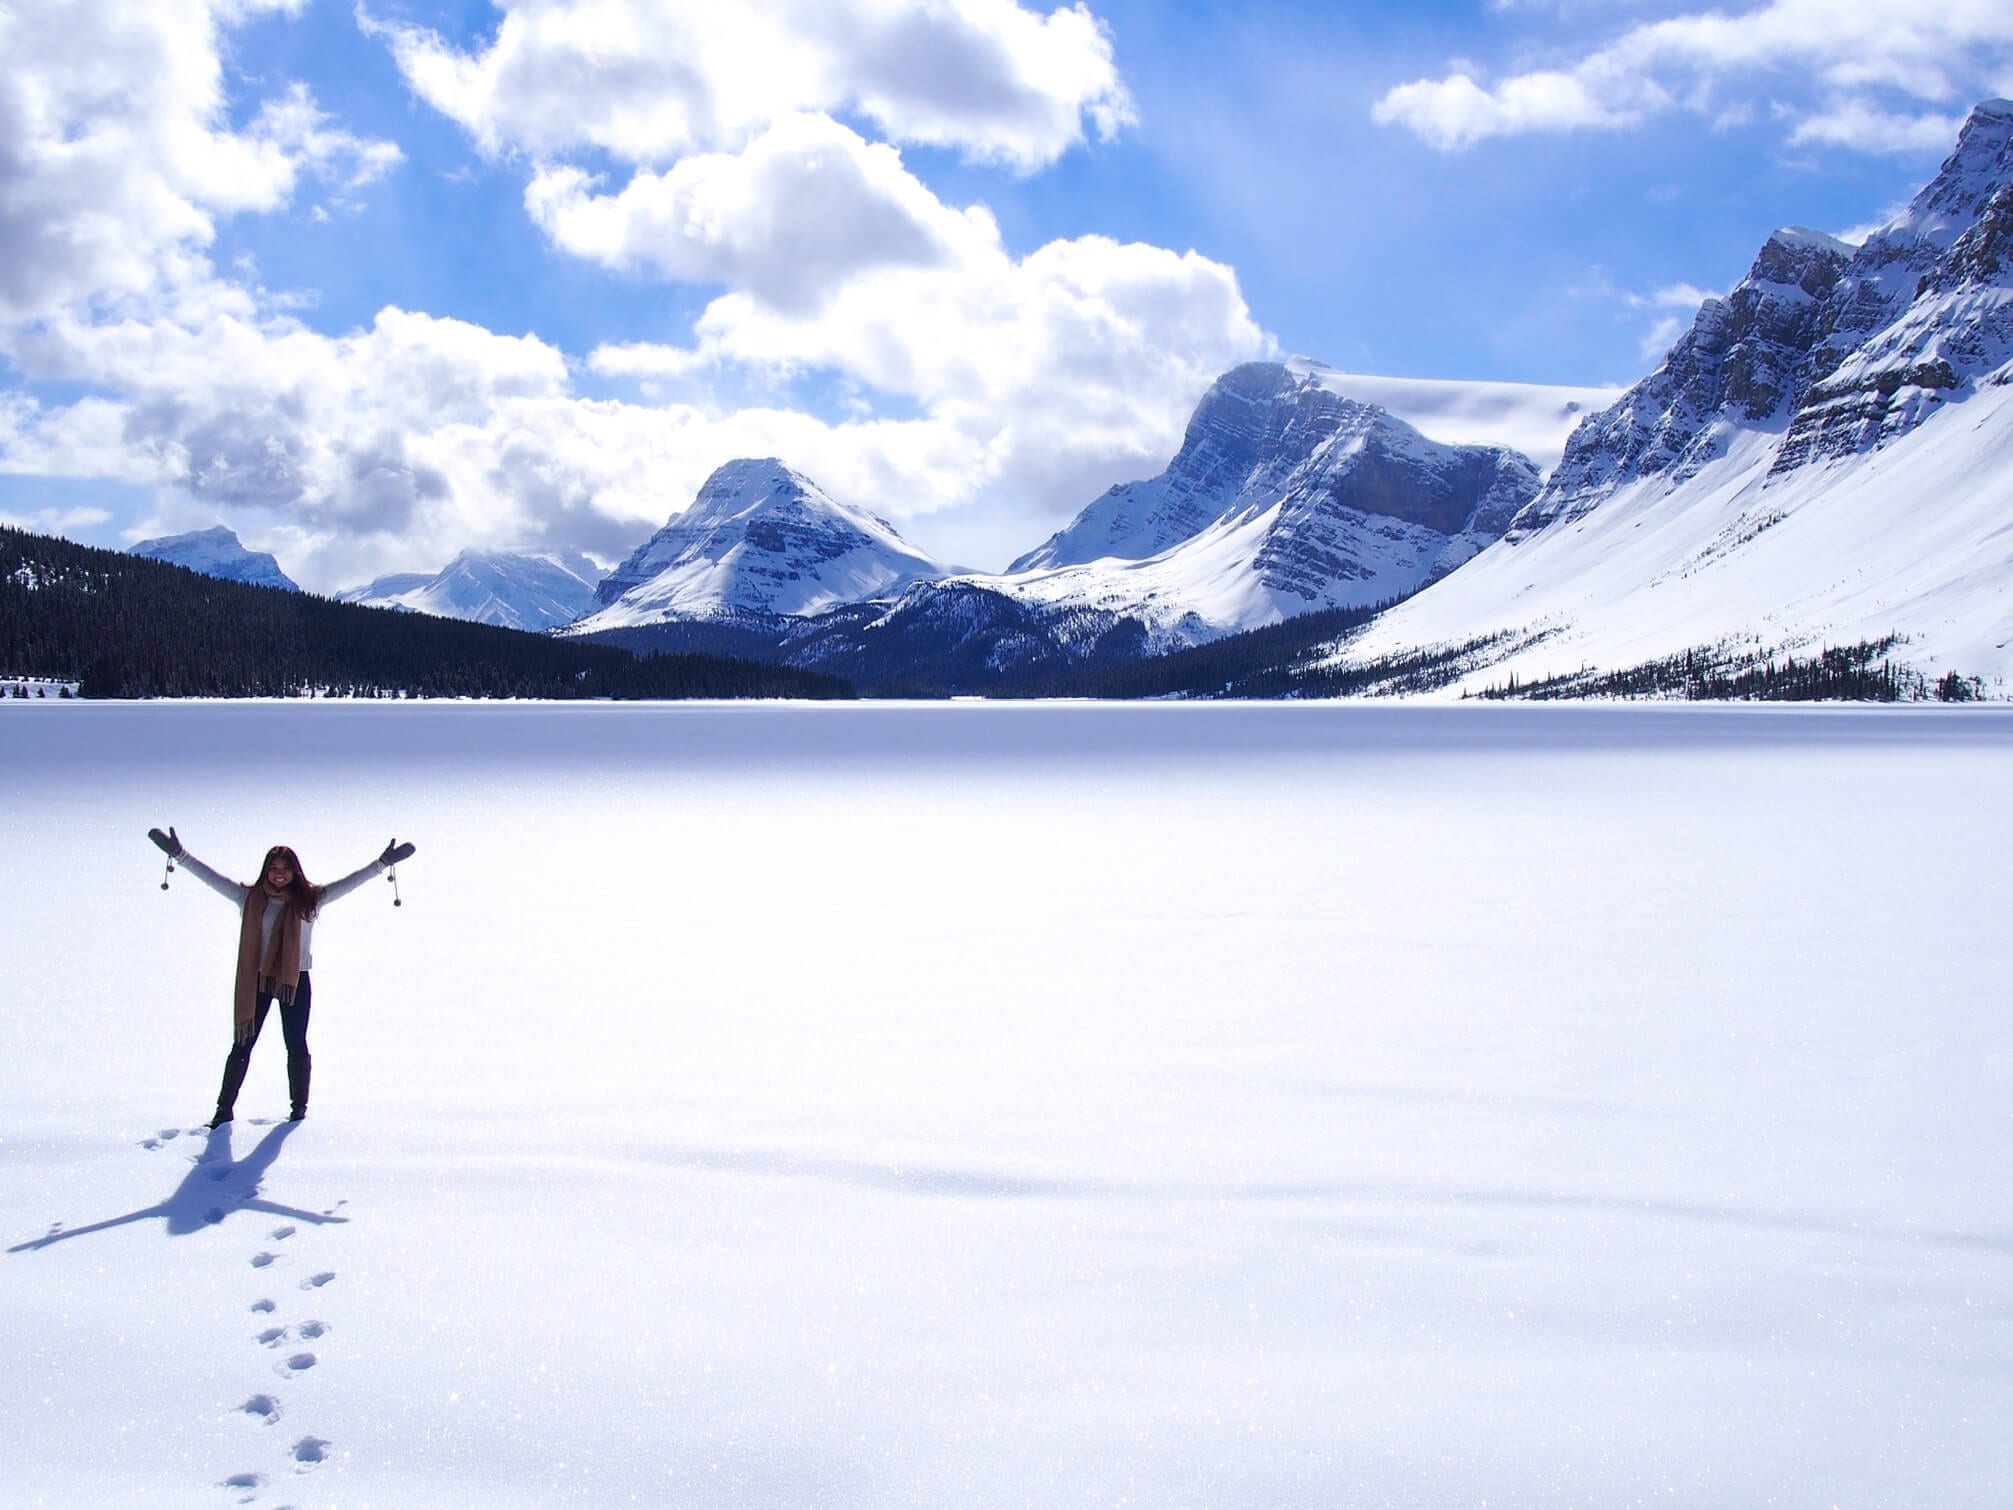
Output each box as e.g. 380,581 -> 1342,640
0,0 -> 1268,586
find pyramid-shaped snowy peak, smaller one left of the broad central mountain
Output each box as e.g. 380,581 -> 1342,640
574,457 -> 950,634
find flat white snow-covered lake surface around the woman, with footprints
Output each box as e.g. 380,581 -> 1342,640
0,701 -> 2013,1510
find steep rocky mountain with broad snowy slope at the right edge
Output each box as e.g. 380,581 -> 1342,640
1343,101 -> 2013,695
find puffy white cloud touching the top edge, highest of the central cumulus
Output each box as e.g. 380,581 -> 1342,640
358,0 -> 1133,171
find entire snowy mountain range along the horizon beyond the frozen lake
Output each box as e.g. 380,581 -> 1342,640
125,101 -> 2013,693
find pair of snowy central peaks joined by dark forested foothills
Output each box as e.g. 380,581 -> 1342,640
566,360 -> 1612,676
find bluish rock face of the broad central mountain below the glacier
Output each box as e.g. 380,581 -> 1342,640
1009,362 -> 1538,604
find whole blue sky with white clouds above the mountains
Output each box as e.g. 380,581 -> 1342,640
0,0 -> 2013,590
